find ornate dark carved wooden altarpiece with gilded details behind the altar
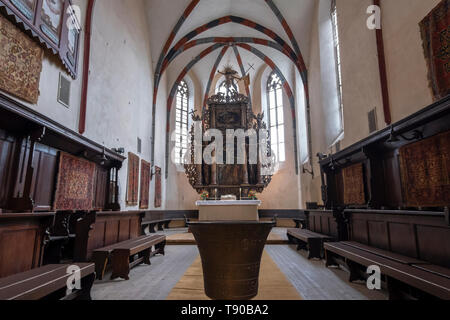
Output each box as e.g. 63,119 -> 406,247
185,67 -> 273,199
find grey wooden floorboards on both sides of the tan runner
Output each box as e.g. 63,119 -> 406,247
92,228 -> 385,300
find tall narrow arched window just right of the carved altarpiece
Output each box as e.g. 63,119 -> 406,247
267,72 -> 286,162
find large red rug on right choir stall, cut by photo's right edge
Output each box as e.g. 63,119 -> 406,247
400,131 -> 450,207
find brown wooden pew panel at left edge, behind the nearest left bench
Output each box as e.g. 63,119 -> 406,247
0,213 -> 54,278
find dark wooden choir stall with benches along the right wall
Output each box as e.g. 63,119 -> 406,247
288,97 -> 450,299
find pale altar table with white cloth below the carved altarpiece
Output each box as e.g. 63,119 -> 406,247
195,200 -> 261,221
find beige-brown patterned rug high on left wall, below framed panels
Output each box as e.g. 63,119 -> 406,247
0,14 -> 44,104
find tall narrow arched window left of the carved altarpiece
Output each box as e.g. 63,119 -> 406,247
175,80 -> 189,164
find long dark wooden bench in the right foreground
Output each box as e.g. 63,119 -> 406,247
324,242 -> 450,300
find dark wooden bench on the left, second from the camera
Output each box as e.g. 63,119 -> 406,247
111,235 -> 166,280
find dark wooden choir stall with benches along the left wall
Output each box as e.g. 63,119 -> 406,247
0,93 -> 167,300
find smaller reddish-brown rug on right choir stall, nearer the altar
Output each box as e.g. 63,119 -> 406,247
342,163 -> 366,205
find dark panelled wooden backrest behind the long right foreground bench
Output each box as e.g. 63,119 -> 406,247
345,210 -> 450,268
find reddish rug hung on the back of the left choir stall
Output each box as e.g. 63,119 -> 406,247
54,152 -> 95,210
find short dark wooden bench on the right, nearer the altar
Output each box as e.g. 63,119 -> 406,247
287,228 -> 333,259
